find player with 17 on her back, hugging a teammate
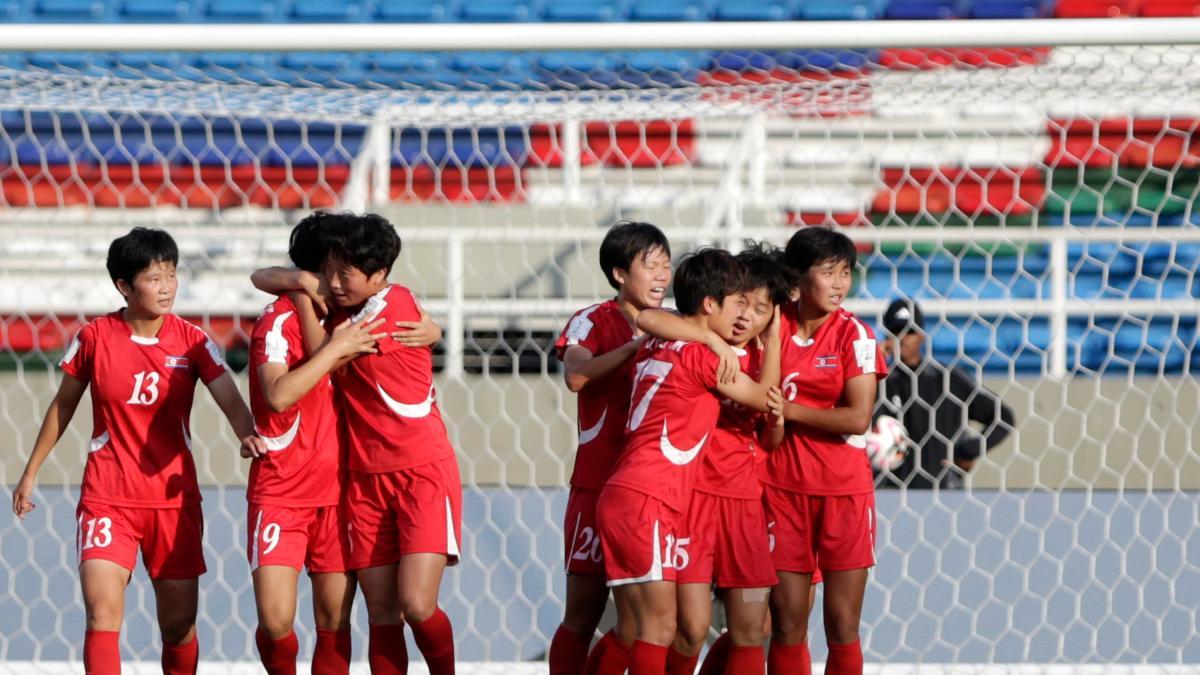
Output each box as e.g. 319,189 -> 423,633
589,249 -> 767,675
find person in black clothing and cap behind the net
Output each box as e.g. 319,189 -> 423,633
875,299 -> 1015,489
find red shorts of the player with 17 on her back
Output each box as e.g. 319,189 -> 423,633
596,485 -> 684,586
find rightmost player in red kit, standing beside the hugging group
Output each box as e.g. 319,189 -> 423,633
763,227 -> 887,675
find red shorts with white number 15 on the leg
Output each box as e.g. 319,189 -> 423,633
676,490 -> 779,589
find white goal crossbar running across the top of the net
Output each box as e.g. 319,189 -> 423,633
0,18 -> 1200,52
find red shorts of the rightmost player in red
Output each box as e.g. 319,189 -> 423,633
763,485 -> 875,574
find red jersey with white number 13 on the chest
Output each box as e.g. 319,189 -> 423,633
60,310 -> 227,508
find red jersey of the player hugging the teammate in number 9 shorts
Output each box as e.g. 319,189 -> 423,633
325,285 -> 454,473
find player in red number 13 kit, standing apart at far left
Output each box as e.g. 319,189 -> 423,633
12,227 -> 264,675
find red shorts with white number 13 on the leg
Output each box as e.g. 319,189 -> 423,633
76,500 -> 208,579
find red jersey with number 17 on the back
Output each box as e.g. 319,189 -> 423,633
608,339 -> 721,513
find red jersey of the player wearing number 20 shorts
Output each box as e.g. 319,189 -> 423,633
554,300 -> 634,490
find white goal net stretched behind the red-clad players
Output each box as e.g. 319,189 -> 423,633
0,20 -> 1200,671
